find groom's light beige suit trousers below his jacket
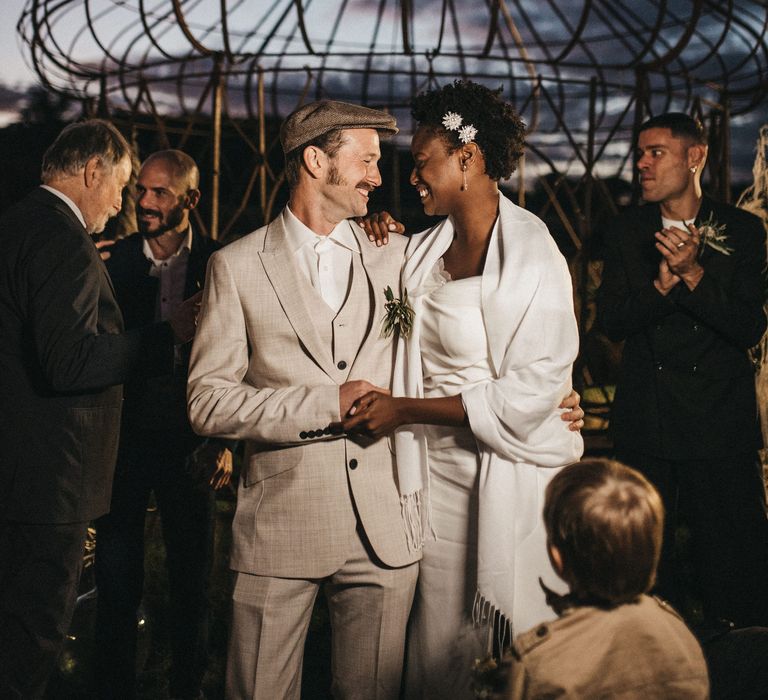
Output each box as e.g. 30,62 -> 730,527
226,529 -> 418,700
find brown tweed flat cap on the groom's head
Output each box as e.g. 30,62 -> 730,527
280,100 -> 397,153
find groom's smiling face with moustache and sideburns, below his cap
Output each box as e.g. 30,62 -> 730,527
323,129 -> 381,221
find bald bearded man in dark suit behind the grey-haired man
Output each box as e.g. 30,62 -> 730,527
96,150 -> 232,699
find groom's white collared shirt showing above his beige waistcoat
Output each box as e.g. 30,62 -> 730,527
283,202 -> 360,313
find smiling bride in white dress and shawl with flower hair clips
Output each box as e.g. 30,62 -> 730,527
344,81 -> 583,698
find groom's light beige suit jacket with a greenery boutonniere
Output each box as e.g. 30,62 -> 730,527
188,215 -> 420,578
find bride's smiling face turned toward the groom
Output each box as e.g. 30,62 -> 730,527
410,126 -> 462,216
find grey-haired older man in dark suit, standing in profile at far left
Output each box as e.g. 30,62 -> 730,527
0,120 -> 196,699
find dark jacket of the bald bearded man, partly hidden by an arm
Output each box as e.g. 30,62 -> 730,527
106,227 -> 221,451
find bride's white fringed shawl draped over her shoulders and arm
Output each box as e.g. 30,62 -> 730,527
393,191 -> 584,634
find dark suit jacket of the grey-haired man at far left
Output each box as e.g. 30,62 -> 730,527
0,188 -> 173,523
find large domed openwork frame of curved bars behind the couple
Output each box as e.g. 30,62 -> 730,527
18,0 -> 768,438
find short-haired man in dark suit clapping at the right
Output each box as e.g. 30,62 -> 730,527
599,113 -> 768,626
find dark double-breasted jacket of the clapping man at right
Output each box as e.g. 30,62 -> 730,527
598,197 -> 766,459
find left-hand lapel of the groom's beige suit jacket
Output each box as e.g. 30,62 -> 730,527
259,223 -> 334,377
